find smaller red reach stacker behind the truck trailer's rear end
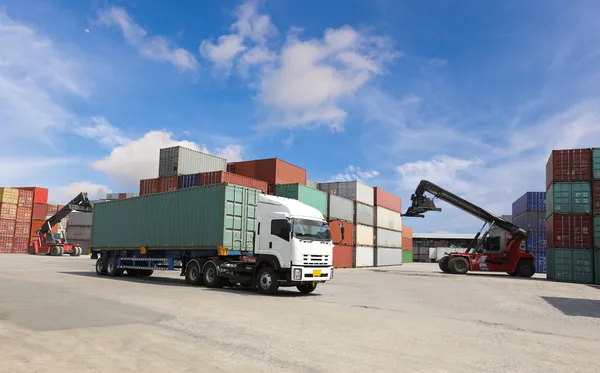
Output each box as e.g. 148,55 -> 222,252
29,193 -> 92,256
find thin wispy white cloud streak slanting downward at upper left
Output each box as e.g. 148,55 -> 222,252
97,7 -> 199,71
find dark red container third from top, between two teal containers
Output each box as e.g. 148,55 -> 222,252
546,214 -> 594,249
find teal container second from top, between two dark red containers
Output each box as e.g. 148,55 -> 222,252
546,183 -> 592,218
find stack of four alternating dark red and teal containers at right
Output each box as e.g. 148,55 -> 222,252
546,149 -> 594,284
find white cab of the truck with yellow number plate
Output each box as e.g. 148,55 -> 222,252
254,195 -> 333,291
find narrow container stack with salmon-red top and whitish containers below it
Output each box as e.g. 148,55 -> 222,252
373,187 -> 402,267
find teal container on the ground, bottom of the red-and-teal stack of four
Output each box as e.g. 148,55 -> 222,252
546,249 -> 594,284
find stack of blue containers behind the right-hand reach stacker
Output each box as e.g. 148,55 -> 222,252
512,192 -> 546,273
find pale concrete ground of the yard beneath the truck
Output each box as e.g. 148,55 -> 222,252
0,255 -> 600,373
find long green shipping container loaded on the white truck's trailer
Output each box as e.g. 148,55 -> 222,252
91,184 -> 261,254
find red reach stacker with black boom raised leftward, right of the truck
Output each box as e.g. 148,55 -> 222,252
402,180 -> 535,277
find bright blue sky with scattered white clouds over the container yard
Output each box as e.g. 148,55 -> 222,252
0,0 -> 600,232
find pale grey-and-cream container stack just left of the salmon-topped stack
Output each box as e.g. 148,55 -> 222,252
318,181 -> 376,267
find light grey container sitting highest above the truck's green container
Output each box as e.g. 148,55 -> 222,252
158,146 -> 227,177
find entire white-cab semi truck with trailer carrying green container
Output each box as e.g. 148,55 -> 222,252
90,183 -> 343,294
